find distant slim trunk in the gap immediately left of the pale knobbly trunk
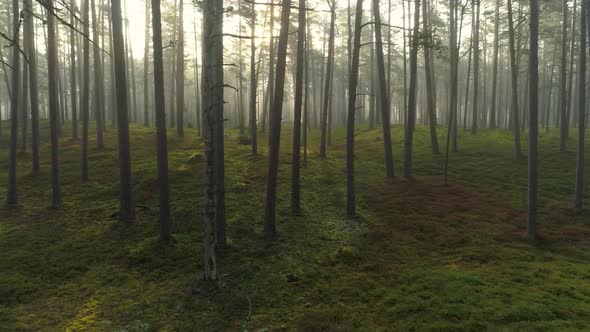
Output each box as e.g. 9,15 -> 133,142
176,0 -> 184,137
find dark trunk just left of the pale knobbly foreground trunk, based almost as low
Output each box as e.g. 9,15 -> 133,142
151,0 -> 172,243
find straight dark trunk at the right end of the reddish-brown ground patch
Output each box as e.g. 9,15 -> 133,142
528,0 -> 544,241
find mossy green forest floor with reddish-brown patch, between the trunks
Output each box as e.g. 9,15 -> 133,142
0,124 -> 590,331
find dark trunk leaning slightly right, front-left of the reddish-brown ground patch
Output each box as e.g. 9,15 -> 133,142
346,0 -> 363,217
